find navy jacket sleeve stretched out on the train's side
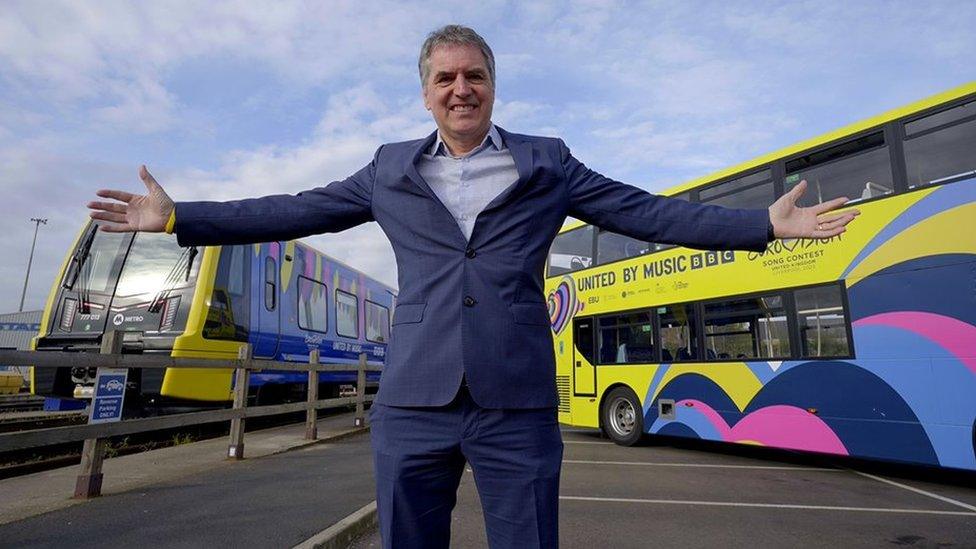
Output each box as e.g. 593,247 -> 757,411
174,147 -> 382,246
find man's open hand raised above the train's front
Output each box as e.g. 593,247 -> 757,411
88,166 -> 174,233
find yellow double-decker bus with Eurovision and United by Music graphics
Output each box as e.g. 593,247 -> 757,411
546,82 -> 976,470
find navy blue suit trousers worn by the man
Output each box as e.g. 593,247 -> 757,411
370,386 -> 563,549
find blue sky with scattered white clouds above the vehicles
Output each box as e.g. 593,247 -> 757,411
0,1 -> 976,312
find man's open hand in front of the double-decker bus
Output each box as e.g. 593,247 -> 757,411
769,181 -> 861,238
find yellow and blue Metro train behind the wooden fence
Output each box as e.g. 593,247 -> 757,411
31,223 -> 396,406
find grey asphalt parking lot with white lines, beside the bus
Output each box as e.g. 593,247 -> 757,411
355,430 -> 976,548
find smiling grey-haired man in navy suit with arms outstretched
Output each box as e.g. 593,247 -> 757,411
89,25 -> 856,547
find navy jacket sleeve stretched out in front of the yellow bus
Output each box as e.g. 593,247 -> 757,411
559,140 -> 769,251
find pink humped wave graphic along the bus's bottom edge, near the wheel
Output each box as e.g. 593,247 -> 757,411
675,399 -> 848,456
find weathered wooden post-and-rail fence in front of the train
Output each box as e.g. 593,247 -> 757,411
0,331 -> 381,498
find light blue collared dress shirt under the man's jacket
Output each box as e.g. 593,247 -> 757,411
417,124 -> 518,240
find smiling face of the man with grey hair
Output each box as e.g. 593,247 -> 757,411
424,45 -> 495,154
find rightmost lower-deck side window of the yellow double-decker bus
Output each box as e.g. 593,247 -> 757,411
793,284 -> 854,358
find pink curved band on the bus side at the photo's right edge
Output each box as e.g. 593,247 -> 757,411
854,311 -> 976,374
